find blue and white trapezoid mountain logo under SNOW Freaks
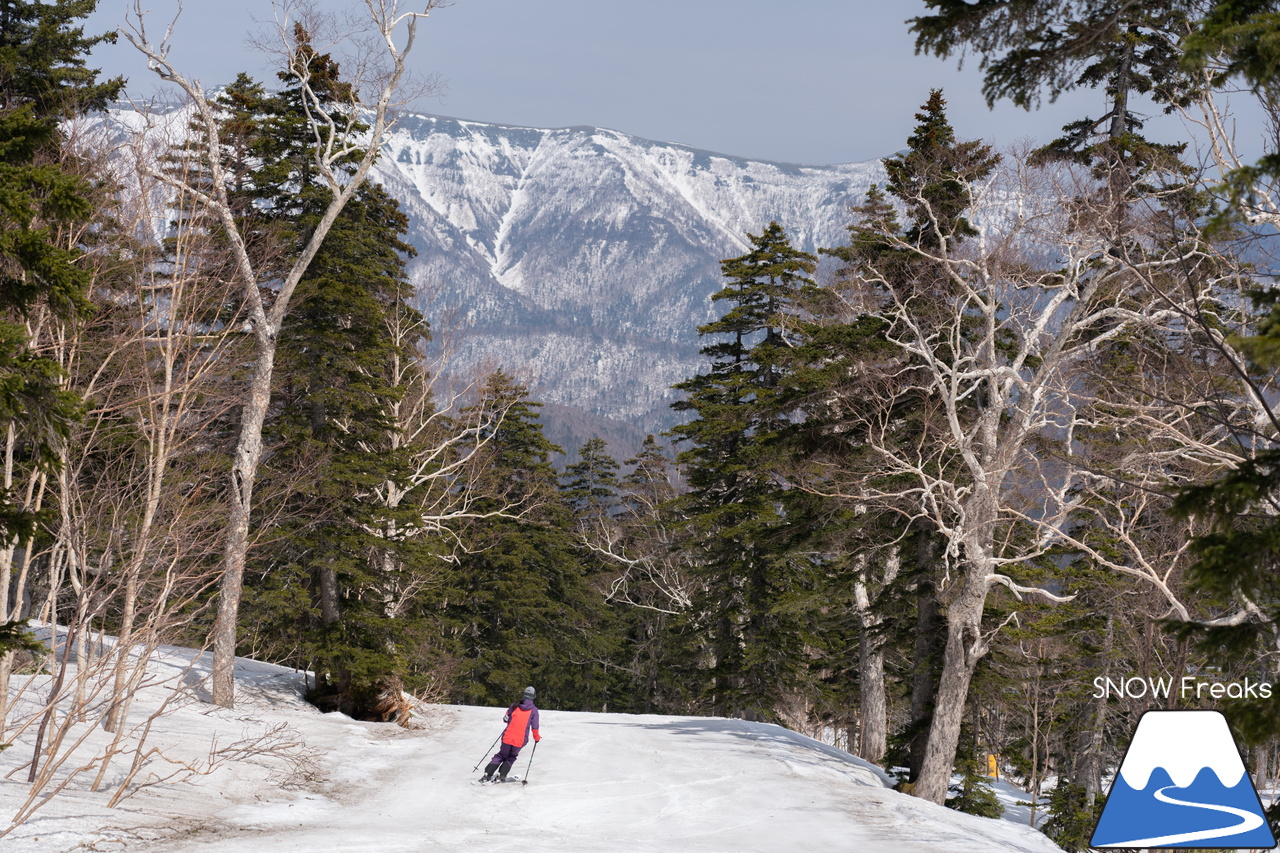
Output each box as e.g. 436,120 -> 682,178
1089,711 -> 1276,850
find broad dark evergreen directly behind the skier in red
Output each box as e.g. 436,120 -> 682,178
442,371 -> 616,710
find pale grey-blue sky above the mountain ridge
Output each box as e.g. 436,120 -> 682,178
88,0 -> 1208,164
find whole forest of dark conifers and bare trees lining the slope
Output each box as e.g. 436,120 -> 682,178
0,0 -> 1280,850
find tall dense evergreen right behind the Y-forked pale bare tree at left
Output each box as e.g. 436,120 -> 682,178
219,28 -> 426,713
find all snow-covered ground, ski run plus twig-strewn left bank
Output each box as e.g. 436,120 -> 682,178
0,648 -> 1059,853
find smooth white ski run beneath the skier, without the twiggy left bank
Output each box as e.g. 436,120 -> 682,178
145,707 -> 1055,853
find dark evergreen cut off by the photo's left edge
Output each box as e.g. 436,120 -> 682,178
0,0 -> 124,651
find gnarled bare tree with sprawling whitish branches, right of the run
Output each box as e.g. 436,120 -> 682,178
810,142 -> 1239,803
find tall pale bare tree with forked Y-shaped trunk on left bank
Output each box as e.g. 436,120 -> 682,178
123,0 -> 438,707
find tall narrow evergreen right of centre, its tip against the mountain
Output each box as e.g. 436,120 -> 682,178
672,223 -> 815,720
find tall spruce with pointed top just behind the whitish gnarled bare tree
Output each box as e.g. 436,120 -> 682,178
788,90 -> 998,781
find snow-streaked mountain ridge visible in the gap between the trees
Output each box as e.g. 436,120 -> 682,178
360,115 -> 883,450
